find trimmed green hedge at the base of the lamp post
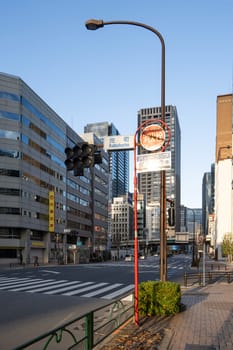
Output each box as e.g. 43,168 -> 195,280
138,281 -> 181,316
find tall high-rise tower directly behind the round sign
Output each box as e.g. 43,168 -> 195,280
138,106 -> 181,239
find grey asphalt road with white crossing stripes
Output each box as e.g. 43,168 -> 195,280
0,255 -> 191,350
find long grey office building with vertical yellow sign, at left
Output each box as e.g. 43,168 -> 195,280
0,73 -> 108,263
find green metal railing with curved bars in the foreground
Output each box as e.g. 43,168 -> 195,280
13,294 -> 134,350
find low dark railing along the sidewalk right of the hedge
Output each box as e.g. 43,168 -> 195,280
184,271 -> 233,287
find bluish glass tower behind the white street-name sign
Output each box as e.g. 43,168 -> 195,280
84,122 -> 129,199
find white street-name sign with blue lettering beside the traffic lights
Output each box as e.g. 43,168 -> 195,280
104,135 -> 134,151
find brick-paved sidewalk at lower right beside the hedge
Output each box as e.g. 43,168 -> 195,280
165,281 -> 233,350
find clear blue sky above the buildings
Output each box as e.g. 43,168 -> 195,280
0,0 -> 233,208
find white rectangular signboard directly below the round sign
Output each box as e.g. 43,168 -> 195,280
136,151 -> 171,173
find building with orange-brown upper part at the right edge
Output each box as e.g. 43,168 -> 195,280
215,94 -> 233,257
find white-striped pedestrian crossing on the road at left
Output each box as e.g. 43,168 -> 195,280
0,276 -> 134,300
